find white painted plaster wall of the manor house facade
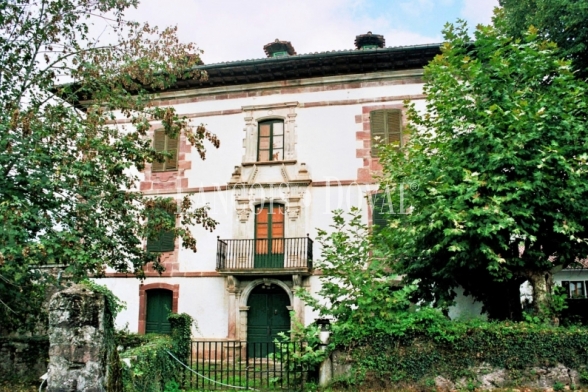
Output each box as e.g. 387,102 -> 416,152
98,71 -> 428,339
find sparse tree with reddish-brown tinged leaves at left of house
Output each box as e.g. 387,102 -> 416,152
0,0 -> 219,329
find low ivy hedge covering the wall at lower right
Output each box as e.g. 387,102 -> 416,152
348,319 -> 588,388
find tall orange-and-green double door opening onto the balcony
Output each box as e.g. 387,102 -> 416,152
253,204 -> 284,268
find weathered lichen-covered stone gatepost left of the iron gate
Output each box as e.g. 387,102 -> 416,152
47,285 -> 107,392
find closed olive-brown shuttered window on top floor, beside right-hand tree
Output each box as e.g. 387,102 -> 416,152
370,109 -> 402,156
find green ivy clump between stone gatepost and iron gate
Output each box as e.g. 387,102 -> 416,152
121,313 -> 192,392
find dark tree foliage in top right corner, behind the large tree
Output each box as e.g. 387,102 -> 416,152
500,0 -> 588,78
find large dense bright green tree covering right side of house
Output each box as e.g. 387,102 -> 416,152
381,18 -> 588,319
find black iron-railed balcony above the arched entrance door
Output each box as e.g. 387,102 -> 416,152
216,237 -> 313,275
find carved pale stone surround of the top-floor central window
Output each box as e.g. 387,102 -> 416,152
242,102 -> 299,166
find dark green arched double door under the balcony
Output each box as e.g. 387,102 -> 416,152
247,285 -> 290,357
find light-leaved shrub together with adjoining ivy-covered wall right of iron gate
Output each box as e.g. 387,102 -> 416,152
306,209 -> 588,390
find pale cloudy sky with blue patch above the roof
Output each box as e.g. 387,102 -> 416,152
127,0 -> 498,64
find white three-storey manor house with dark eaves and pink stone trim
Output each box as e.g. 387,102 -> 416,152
99,33 -> 585,342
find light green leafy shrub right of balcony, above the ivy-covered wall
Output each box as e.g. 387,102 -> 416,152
297,208 -> 444,344
